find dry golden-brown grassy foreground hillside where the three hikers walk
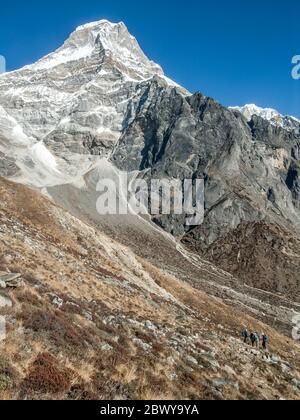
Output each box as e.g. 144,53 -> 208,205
0,179 -> 300,400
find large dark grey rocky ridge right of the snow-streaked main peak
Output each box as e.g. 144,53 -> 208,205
112,80 -> 300,249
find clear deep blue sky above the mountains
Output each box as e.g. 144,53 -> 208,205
0,0 -> 300,118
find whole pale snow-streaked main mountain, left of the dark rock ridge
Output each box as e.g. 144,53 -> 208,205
0,20 -> 187,187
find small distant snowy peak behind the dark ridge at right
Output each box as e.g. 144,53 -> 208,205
229,104 -> 300,131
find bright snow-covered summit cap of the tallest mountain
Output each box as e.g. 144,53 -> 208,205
27,20 -> 164,81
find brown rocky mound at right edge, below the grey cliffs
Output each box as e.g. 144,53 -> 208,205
185,222 -> 300,302
